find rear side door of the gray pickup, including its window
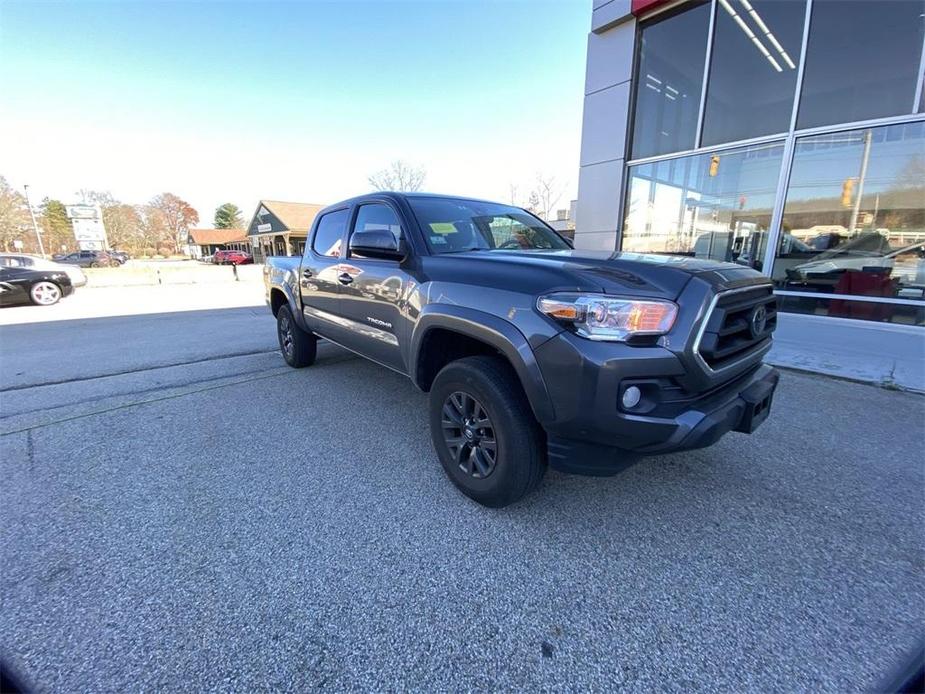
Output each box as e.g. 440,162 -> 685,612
299,207 -> 350,342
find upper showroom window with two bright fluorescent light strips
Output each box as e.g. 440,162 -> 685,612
702,0 -> 806,146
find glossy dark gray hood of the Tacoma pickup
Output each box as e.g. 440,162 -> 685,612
446,249 -> 760,299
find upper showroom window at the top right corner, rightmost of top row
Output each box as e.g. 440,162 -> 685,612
797,0 -> 925,128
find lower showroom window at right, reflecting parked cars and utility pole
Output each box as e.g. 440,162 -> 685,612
773,121 -> 925,308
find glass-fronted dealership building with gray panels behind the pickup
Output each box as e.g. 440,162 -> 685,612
575,0 -> 925,389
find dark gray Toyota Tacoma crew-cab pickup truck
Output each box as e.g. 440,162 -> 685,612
264,193 -> 778,506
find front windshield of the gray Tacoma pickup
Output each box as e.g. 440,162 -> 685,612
409,196 -> 569,253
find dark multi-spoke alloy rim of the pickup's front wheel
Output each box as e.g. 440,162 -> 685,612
442,391 -> 498,479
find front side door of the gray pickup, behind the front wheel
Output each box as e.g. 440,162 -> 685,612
340,202 -> 410,372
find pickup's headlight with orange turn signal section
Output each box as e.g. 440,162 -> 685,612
536,294 -> 678,342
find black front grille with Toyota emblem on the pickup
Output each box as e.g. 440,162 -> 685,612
698,285 -> 777,371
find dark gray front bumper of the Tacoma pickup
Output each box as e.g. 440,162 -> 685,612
538,339 -> 780,475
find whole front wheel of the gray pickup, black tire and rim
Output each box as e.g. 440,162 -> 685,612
429,356 -> 546,508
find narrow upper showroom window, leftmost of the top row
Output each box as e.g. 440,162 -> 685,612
632,4 -> 710,159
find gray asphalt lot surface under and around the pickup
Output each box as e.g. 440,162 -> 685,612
0,294 -> 925,692
